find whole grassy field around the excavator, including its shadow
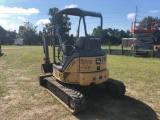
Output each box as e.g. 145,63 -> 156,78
0,46 -> 160,120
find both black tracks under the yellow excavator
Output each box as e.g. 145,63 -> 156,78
39,75 -> 125,113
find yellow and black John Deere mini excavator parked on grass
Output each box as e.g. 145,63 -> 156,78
39,8 -> 125,113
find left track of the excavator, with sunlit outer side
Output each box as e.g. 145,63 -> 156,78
39,76 -> 86,114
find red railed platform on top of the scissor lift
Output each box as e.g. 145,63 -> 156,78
131,22 -> 156,34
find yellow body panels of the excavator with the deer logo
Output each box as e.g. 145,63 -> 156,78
53,56 -> 109,86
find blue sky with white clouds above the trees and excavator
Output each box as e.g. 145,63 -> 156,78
0,0 -> 160,31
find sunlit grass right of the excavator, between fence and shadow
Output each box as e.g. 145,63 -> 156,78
108,55 -> 160,115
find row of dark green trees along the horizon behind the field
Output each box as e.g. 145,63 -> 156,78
0,7 -> 160,45
